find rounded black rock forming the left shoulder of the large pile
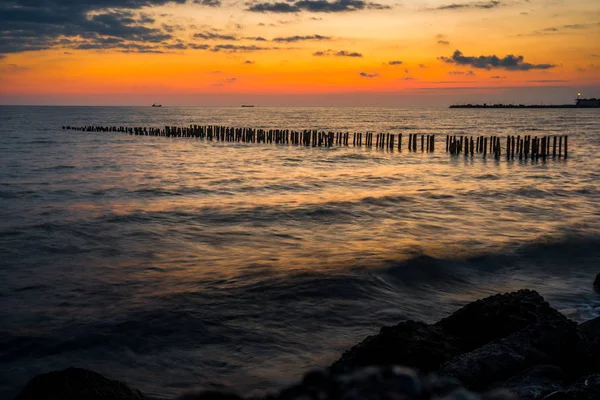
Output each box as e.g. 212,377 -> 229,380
331,321 -> 461,372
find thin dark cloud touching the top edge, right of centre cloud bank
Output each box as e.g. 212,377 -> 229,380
247,0 -> 391,14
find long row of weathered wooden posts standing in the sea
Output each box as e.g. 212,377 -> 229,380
62,125 -> 568,159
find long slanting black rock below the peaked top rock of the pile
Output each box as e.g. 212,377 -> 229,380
440,316 -> 577,389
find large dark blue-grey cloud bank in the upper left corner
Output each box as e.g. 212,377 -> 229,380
0,0 -> 220,54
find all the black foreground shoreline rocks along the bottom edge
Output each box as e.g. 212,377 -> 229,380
15,290 -> 600,400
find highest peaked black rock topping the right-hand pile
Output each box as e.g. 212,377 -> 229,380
435,290 -> 565,351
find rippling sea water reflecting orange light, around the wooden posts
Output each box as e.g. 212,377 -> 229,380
0,107 -> 600,398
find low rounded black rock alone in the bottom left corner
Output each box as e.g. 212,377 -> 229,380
15,367 -> 144,400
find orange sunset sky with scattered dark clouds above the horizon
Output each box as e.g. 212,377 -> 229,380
0,0 -> 600,106
